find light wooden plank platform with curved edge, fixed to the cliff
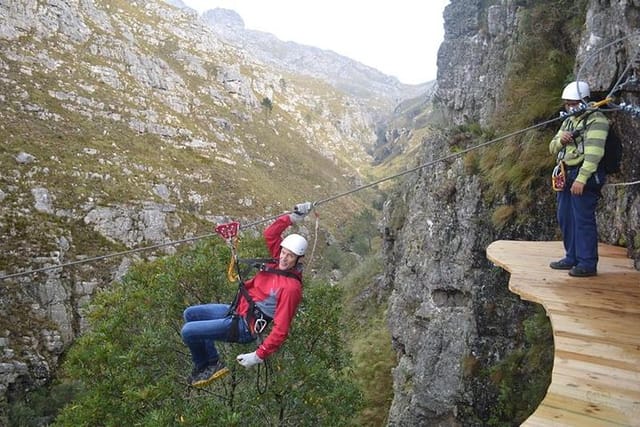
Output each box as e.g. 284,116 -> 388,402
487,240 -> 640,427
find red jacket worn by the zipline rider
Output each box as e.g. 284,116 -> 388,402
238,215 -> 302,360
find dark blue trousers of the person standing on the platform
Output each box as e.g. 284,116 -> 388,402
558,168 -> 605,271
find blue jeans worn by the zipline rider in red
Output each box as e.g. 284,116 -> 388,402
181,304 -> 254,369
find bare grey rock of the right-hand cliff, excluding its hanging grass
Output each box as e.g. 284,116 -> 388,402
385,0 -> 640,426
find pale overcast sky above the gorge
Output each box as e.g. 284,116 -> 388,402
182,0 -> 449,84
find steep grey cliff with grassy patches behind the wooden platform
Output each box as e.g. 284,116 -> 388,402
385,0 -> 640,426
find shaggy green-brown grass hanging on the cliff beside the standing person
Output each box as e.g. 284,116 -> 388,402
451,1 -> 586,229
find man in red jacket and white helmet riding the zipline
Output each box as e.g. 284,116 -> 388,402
181,202 -> 313,387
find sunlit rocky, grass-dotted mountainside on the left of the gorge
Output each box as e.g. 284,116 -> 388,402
0,0 -> 416,416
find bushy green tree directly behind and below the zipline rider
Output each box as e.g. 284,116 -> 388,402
55,239 -> 361,426
